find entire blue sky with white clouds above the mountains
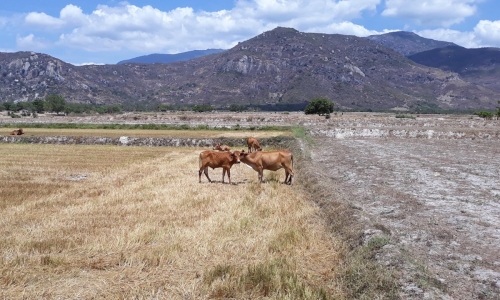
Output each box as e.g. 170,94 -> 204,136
0,0 -> 500,65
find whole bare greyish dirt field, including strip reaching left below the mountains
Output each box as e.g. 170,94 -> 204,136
0,113 -> 500,299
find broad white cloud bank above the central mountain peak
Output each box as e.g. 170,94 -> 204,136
18,0 -> 381,53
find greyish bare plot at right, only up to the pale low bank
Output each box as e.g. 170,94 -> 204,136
311,136 -> 500,299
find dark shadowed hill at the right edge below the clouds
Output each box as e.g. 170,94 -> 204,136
408,46 -> 500,92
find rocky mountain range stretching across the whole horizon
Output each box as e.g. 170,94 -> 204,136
0,27 -> 500,111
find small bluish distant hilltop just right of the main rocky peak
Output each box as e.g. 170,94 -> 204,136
366,31 -> 456,56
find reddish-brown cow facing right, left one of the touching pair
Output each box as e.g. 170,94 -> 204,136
198,150 -> 240,184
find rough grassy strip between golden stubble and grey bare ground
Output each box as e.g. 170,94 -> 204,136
297,145 -> 400,299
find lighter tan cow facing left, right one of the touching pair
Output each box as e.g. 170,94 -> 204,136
240,150 -> 293,185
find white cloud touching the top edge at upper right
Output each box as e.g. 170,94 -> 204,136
382,0 -> 482,27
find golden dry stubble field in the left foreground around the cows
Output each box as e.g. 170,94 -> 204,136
0,144 -> 344,299
